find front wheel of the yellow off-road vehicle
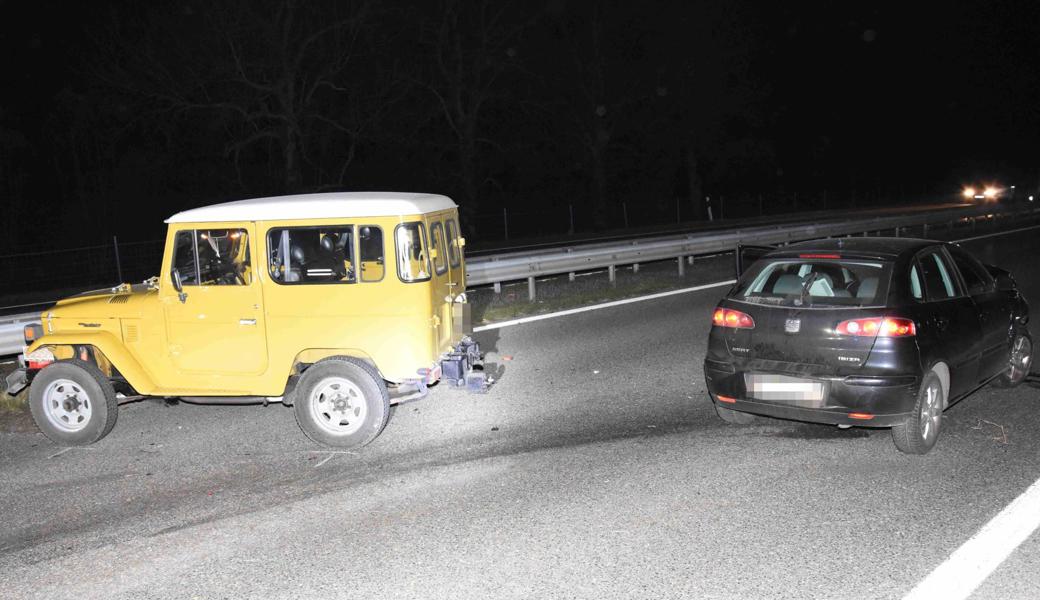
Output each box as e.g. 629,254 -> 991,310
29,360 -> 120,446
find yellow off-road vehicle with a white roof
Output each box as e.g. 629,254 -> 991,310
7,192 -> 489,446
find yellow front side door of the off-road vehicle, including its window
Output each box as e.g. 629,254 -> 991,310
162,224 -> 267,375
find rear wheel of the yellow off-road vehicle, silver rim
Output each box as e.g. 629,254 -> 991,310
292,357 -> 390,448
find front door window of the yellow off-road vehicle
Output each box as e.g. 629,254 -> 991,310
174,229 -> 253,285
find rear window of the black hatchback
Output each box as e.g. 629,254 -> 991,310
731,258 -> 891,307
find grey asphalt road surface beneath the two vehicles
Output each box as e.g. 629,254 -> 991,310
0,230 -> 1040,599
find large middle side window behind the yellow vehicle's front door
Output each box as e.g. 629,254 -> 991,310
267,225 -> 357,285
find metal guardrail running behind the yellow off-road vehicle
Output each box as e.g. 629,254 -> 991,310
0,207 -> 1040,356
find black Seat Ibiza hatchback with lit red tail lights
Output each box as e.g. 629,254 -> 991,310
704,237 -> 1033,454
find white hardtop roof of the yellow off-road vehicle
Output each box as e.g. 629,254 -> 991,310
166,191 -> 456,223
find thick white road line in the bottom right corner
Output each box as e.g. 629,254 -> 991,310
904,479 -> 1040,600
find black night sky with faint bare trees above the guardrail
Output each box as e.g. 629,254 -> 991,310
0,0 -> 1040,247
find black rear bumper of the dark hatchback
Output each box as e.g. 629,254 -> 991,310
704,361 -> 920,427
